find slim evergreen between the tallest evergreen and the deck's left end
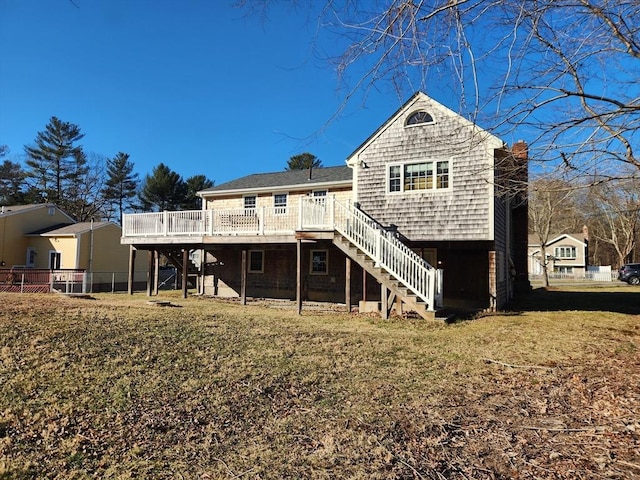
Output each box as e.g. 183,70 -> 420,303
102,152 -> 139,222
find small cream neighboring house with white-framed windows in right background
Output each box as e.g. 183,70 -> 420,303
528,231 -> 589,277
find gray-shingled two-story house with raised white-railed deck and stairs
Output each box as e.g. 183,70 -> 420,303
122,92 -> 527,318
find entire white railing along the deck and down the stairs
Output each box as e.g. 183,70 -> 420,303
122,196 -> 442,310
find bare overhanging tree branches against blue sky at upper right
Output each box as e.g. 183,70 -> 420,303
238,0 -> 640,183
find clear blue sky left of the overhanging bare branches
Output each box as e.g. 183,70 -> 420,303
0,0 -> 412,184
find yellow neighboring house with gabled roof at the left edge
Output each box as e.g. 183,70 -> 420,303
0,204 -> 138,284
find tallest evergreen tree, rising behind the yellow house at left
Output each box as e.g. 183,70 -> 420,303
24,117 -> 86,206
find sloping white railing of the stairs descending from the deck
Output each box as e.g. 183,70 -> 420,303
327,197 -> 442,310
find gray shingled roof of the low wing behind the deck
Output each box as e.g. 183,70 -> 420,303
199,166 -> 353,194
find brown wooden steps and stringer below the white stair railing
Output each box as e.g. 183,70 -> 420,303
333,232 -> 436,320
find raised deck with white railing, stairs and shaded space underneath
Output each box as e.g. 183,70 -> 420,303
122,197 -> 442,317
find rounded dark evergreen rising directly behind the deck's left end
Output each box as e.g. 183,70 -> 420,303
140,163 -> 187,211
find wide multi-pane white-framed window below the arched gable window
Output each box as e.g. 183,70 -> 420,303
387,160 -> 450,193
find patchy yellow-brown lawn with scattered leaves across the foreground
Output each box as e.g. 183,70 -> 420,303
0,286 -> 640,480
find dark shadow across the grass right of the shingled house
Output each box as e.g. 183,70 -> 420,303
508,287 -> 640,315
